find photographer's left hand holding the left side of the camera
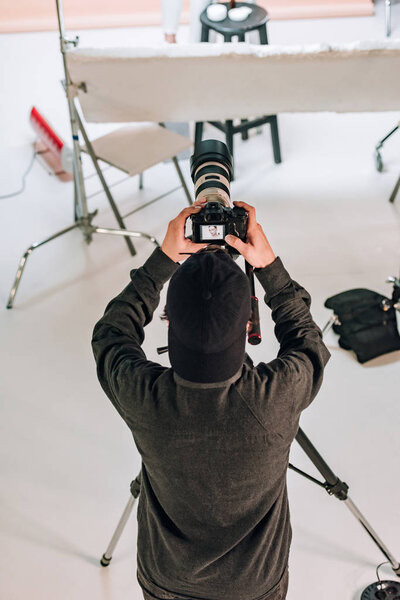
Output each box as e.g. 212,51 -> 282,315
161,200 -> 207,262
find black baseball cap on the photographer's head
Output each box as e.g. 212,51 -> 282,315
166,250 -> 251,383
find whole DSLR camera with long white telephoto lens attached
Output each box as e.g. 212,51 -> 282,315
190,140 -> 248,248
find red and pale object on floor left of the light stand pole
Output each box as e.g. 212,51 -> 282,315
29,106 -> 73,181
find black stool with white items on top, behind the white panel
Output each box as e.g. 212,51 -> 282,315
194,2 -> 282,175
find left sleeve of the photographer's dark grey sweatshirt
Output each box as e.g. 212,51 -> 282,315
92,248 -> 179,425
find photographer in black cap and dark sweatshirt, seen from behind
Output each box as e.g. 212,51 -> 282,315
92,201 -> 329,600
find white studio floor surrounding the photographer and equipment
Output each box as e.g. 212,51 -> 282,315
0,1 -> 400,600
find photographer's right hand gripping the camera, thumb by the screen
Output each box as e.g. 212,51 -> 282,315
225,202 -> 276,269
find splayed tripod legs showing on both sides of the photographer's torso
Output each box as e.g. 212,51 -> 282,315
100,429 -> 400,577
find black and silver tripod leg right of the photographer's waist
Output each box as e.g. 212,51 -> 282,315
290,429 -> 400,577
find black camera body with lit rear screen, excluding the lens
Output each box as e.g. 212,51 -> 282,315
191,201 -> 248,241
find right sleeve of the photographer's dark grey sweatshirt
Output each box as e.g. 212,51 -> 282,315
255,257 -> 330,431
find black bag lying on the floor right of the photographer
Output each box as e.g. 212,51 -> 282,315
325,288 -> 400,363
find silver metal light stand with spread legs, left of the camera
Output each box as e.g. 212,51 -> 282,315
7,0 -> 159,308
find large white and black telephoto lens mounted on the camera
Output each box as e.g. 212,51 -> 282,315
190,140 -> 232,207
